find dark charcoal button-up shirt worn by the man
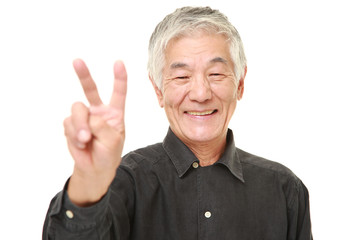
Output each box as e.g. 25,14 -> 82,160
43,130 -> 312,240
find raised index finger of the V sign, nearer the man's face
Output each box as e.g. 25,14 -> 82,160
110,61 -> 127,111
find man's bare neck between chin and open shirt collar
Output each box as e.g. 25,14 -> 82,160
184,133 -> 226,167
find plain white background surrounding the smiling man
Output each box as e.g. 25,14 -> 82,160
0,0 -> 360,240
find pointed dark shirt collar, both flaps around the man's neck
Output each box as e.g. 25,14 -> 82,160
163,128 -> 244,182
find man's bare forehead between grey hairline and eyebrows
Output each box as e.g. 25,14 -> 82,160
165,33 -> 231,67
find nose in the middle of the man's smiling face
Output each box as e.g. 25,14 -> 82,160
188,76 -> 212,102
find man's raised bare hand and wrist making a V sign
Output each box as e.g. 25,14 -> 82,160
64,59 -> 127,206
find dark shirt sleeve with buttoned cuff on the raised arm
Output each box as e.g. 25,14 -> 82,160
43,166 -> 133,240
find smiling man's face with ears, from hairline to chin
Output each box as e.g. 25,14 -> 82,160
155,33 -> 243,144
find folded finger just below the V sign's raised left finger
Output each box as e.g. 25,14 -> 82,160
71,102 -> 91,145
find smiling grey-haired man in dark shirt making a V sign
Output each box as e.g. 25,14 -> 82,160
43,7 -> 312,240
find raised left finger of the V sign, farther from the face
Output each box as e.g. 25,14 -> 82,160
73,59 -> 102,105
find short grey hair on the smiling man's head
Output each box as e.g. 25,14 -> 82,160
148,7 -> 246,89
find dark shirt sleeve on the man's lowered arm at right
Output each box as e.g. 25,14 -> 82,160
287,180 -> 313,240
